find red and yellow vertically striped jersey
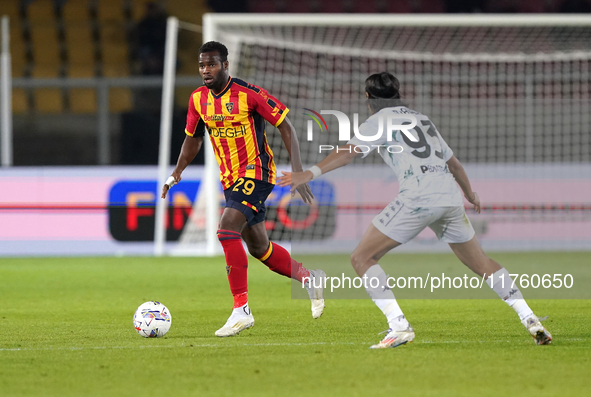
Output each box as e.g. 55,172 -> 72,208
185,78 -> 289,189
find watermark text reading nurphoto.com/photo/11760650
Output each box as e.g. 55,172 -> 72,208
302,273 -> 574,292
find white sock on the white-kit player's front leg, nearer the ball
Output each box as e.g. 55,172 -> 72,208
363,264 -> 409,331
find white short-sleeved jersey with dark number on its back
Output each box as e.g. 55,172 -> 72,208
348,106 -> 464,208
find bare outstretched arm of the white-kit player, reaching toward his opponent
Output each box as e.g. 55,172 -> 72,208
277,144 -> 359,193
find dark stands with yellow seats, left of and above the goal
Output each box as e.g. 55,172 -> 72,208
0,0 -> 591,166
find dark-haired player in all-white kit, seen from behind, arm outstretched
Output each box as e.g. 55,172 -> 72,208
278,72 -> 552,348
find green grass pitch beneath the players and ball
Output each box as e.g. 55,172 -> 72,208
0,253 -> 591,397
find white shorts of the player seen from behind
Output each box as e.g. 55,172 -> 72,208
372,199 -> 475,244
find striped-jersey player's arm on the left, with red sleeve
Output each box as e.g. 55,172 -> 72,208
160,94 -> 205,198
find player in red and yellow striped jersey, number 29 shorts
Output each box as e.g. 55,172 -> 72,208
162,41 -> 325,337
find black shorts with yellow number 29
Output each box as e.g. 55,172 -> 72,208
224,178 -> 275,226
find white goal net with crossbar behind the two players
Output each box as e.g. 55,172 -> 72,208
164,14 -> 591,252
